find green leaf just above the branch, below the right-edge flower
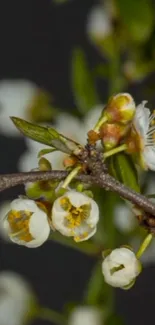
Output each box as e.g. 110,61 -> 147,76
108,153 -> 140,192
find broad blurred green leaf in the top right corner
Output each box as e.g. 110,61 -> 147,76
115,0 -> 154,42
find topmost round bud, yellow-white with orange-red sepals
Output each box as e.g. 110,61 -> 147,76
103,93 -> 136,124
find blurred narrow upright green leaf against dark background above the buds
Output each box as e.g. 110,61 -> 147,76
72,49 -> 100,114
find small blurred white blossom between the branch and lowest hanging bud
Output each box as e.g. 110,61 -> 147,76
114,203 -> 137,233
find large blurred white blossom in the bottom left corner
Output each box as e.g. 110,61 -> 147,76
0,271 -> 33,325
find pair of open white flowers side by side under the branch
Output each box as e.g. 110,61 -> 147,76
3,190 -> 99,248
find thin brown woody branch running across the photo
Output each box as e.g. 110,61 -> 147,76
0,170 -> 155,216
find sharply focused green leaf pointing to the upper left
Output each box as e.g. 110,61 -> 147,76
11,117 -> 83,155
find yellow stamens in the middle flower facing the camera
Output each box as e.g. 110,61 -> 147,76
60,198 -> 91,229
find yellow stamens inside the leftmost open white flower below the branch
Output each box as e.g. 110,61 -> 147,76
7,210 -> 34,242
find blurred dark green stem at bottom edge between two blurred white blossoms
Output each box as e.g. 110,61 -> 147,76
36,307 -> 66,325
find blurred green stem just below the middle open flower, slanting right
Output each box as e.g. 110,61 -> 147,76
49,232 -> 101,255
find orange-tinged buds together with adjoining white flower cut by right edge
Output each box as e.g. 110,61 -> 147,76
92,93 -> 155,170
